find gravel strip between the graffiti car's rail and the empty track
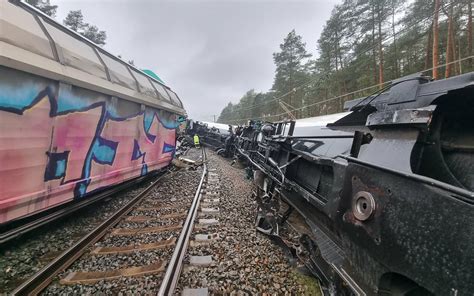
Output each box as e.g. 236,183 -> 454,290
0,180 -> 158,294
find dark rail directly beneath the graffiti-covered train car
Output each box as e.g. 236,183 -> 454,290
0,176 -> 156,246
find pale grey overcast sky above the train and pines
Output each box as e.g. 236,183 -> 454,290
51,0 -> 341,121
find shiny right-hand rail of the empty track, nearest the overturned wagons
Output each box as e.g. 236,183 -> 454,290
158,147 -> 207,296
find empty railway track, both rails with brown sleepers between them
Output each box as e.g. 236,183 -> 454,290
12,149 -> 210,295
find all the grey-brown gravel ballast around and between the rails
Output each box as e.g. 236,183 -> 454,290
0,149 -> 319,295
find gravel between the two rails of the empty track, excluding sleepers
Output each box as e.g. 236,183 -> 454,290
43,155 -> 202,295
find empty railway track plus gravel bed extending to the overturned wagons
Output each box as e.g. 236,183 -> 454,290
8,149 -> 317,295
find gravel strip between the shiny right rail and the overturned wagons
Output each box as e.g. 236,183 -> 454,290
175,151 -> 319,295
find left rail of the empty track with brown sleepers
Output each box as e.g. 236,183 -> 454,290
12,170 -> 172,295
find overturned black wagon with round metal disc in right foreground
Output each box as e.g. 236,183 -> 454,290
239,73 -> 474,295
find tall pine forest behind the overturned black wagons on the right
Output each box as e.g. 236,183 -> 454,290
218,0 -> 473,124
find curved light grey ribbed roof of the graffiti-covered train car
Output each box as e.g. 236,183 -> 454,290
0,0 -> 185,115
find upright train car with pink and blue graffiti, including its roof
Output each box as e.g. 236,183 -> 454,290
0,0 -> 185,224
